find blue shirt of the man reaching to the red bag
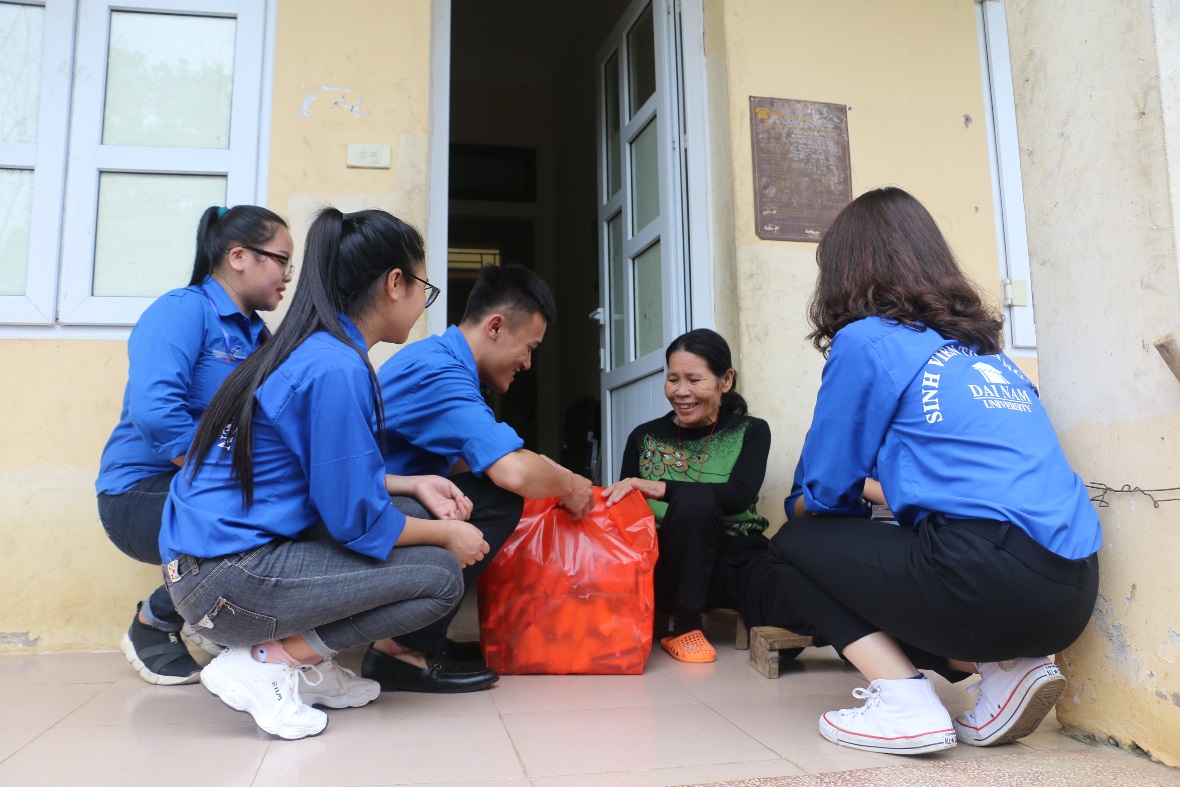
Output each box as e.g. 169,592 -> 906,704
378,326 -> 524,476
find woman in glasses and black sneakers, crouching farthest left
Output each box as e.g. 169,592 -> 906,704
94,205 -> 293,686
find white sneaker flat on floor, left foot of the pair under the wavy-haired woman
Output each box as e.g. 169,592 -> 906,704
819,678 -> 955,754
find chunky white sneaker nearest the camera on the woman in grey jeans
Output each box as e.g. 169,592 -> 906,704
201,648 -> 328,741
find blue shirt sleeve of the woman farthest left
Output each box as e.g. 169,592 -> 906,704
127,295 -> 209,460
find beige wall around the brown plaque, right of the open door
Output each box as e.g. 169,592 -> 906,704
706,0 -> 999,523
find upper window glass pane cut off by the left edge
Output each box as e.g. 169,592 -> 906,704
0,2 -> 45,143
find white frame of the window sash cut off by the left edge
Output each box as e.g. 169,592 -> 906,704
0,0 -> 74,324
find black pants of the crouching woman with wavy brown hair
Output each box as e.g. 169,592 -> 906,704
771,513 -> 1099,678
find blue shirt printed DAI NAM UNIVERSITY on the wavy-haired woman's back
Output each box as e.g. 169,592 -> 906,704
788,317 -> 1102,558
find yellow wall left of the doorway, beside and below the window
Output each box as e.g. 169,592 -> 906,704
0,0 -> 431,652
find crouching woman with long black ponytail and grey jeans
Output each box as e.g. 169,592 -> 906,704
159,208 -> 489,739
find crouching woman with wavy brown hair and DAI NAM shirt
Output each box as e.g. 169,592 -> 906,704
771,188 -> 1102,754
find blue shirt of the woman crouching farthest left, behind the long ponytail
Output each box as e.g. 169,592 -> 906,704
94,277 -> 266,494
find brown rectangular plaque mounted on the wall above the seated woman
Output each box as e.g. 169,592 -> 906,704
749,96 -> 852,243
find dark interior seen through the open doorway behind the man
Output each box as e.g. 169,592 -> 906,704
448,0 -> 627,472
